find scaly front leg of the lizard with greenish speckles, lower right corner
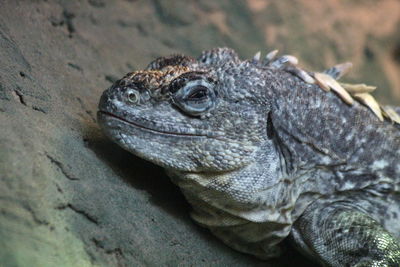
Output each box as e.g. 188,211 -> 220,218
291,201 -> 400,267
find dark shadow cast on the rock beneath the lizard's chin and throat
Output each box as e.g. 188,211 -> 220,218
86,128 -> 316,266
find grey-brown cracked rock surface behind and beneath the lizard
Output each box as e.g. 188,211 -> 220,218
0,0 -> 400,266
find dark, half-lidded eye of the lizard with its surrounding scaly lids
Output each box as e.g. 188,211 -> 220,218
173,80 -> 216,116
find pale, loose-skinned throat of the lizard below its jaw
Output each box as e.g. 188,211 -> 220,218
167,142 -> 300,258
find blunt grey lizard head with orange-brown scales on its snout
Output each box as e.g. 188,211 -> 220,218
98,48 -> 268,172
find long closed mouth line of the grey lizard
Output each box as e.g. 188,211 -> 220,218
97,110 -> 216,137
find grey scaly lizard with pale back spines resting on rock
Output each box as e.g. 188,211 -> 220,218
97,48 -> 400,266
